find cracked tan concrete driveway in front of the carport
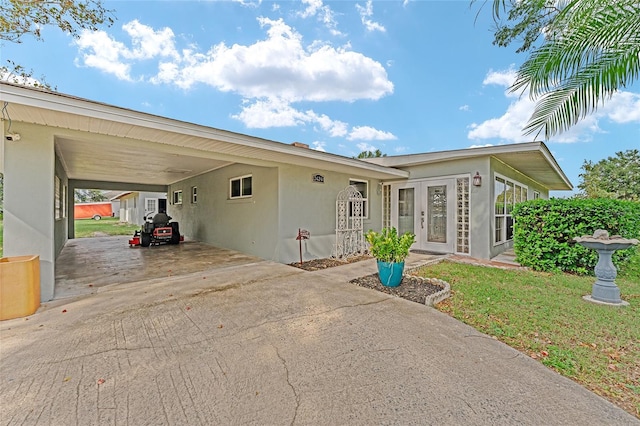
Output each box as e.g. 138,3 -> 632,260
0,240 -> 640,425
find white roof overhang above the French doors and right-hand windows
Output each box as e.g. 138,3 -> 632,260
366,142 -> 573,191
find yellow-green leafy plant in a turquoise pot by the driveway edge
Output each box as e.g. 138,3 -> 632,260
366,227 -> 416,287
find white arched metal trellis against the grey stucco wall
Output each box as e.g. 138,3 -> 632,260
334,185 -> 367,259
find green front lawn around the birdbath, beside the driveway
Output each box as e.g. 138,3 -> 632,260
419,252 -> 640,417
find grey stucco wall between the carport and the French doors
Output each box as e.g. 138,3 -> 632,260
167,163 -> 381,263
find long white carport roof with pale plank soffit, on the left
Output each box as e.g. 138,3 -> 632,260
0,82 -> 408,185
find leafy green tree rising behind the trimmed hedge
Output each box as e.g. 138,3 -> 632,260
578,149 -> 640,201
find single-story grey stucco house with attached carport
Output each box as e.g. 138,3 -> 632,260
0,83 -> 572,301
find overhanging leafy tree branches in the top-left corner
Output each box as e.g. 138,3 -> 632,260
0,0 -> 115,89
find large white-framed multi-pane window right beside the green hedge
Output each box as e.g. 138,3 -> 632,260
493,176 -> 527,244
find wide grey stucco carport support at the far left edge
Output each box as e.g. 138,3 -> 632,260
3,126 -> 55,302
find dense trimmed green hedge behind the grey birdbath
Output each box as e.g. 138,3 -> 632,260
512,198 -> 640,274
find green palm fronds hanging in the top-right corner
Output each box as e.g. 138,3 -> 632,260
511,0 -> 640,139
